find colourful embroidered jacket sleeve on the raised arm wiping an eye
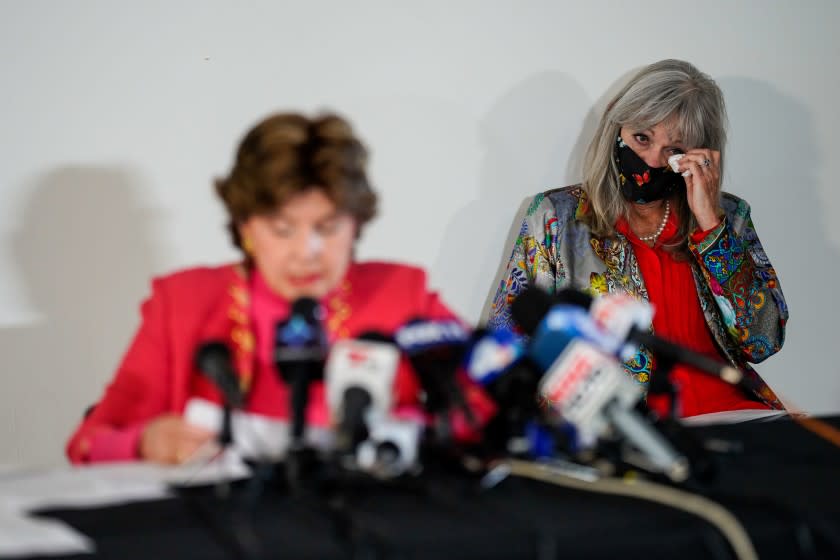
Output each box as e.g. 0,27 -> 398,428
689,194 -> 788,363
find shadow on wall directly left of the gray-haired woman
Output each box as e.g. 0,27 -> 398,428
435,72 -> 590,321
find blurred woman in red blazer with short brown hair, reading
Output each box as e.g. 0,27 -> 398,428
67,114 -> 492,463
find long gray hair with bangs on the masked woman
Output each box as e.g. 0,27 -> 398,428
583,60 -> 727,246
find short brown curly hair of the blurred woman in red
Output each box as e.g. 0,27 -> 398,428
216,113 -> 376,249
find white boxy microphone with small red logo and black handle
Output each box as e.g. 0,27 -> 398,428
325,332 -> 400,454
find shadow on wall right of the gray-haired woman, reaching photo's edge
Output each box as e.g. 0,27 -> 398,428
718,77 -> 840,412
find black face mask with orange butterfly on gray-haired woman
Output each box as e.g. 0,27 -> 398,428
615,136 -> 685,203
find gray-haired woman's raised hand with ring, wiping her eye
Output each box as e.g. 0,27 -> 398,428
678,148 -> 721,231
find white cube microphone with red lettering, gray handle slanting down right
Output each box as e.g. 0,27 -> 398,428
540,340 -> 690,482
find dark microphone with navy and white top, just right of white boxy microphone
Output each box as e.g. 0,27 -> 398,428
395,319 -> 477,441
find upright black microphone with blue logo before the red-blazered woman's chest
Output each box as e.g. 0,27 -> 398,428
274,298 -> 327,449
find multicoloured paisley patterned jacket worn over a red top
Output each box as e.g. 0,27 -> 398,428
488,186 -> 788,409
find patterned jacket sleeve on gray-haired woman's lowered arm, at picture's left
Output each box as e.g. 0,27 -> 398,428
487,193 -> 558,329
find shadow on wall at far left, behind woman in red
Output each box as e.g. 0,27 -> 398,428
0,167 -> 164,465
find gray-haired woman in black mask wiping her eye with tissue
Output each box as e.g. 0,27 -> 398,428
489,60 -> 788,416
